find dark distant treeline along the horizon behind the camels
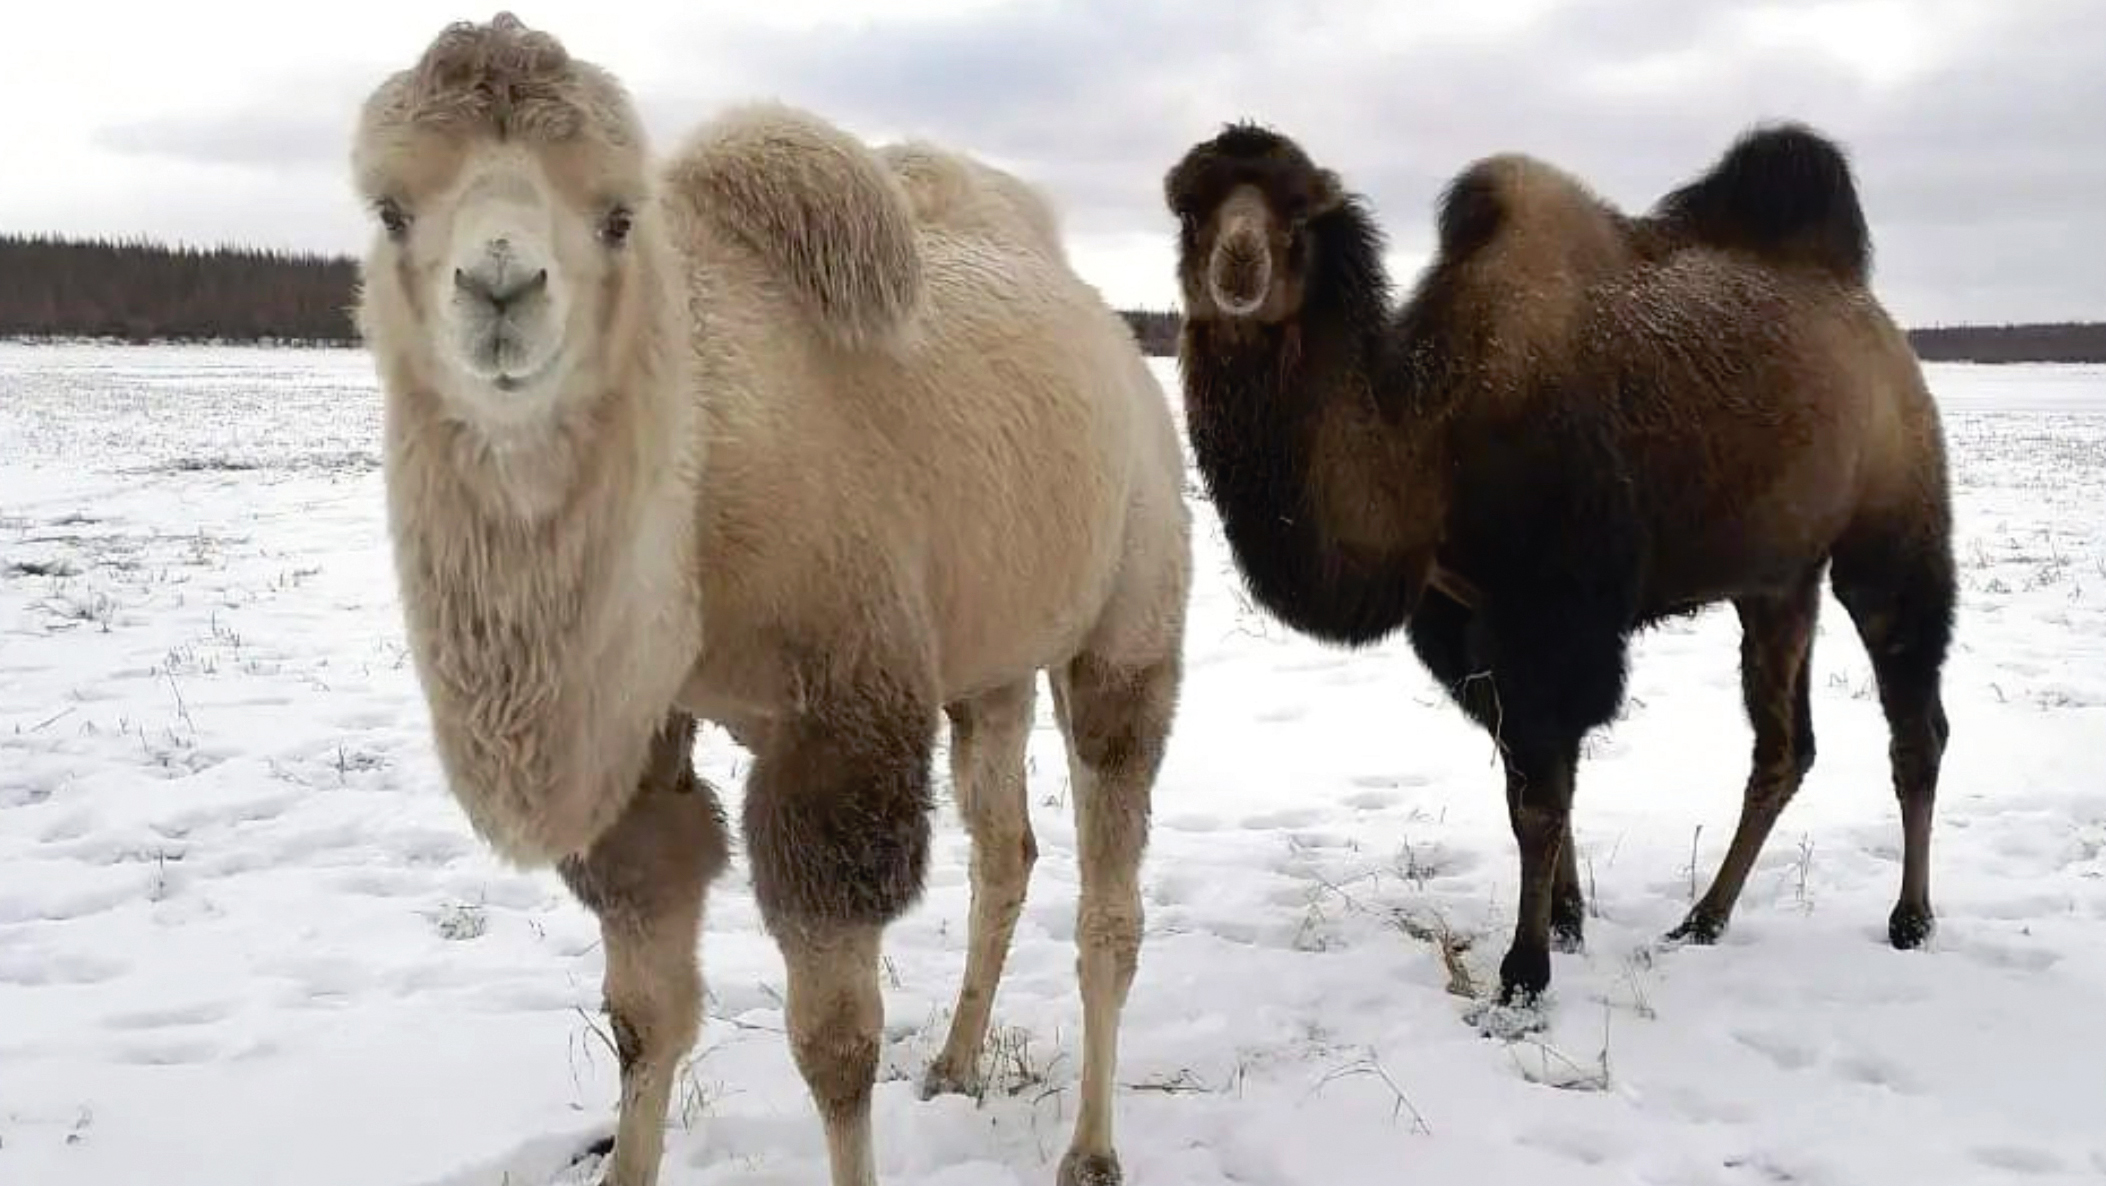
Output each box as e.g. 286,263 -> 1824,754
0,236 -> 2106,362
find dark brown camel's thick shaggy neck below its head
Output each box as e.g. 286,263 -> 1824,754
1181,204 -> 1447,645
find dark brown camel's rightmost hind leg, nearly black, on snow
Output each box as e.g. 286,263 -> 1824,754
1834,520 -> 1956,950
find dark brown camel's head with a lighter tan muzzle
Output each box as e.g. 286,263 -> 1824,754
1163,124 -> 1346,324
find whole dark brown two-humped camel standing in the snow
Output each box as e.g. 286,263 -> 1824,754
1165,124 -> 1954,1001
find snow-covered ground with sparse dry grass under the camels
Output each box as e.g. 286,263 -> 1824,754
0,339 -> 2106,1186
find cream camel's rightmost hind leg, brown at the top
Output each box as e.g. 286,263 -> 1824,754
1051,655 -> 1181,1186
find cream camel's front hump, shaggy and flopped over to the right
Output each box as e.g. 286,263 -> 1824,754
665,103 -> 922,350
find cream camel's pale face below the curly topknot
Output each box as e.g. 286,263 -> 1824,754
369,139 -> 632,423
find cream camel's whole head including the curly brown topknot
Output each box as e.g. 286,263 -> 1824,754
352,13 -> 649,421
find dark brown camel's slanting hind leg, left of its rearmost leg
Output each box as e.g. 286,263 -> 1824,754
1668,571 -> 1822,944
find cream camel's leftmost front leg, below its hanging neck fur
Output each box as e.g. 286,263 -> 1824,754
558,712 -> 727,1186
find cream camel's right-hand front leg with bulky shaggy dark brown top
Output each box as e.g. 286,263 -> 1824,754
743,676 -> 937,1186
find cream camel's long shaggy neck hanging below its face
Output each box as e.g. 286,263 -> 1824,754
388,320 -> 699,864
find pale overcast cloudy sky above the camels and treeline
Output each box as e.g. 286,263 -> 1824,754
0,0 -> 2106,324
